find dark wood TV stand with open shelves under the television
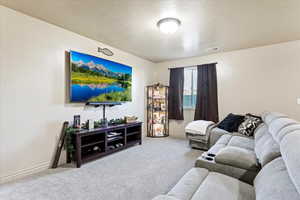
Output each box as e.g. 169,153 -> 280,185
72,122 -> 142,168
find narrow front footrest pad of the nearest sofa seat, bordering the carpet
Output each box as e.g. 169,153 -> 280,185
168,168 -> 209,200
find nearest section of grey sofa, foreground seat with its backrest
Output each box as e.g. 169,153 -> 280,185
154,130 -> 300,200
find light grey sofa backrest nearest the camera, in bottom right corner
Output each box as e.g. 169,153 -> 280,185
254,130 -> 300,200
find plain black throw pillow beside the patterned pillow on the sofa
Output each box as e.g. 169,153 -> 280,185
218,113 -> 245,132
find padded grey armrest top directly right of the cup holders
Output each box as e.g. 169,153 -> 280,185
215,146 -> 260,171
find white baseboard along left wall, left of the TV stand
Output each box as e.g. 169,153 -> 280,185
0,161 -> 50,184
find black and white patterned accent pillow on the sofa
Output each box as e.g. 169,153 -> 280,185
238,114 -> 262,137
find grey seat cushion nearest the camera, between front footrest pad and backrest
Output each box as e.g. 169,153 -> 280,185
191,172 -> 255,200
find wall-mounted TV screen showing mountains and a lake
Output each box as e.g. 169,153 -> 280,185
70,51 -> 132,103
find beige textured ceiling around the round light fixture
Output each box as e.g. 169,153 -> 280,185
0,0 -> 300,62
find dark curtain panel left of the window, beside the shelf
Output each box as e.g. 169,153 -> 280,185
168,68 -> 184,120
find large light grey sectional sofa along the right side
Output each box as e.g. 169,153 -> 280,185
155,113 -> 300,200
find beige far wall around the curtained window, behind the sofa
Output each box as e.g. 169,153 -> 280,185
156,41 -> 300,137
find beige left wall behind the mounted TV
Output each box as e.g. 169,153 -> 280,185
0,6 -> 154,182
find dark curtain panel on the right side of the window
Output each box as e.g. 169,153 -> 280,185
194,63 -> 219,122
